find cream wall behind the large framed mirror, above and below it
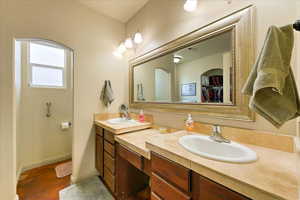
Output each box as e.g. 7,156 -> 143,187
126,0 -> 297,135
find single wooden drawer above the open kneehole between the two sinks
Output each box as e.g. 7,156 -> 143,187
118,144 -> 143,170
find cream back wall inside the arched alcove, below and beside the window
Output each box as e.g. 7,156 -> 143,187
16,41 -> 73,172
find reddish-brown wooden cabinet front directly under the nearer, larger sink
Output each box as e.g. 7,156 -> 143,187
151,153 -> 249,200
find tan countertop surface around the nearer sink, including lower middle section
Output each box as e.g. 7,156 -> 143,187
116,129 -> 300,200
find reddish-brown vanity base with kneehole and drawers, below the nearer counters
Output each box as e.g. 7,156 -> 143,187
117,144 -> 249,200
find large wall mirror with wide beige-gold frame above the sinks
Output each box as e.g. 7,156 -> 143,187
129,7 -> 254,121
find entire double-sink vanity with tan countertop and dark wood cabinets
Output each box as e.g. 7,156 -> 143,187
95,113 -> 299,200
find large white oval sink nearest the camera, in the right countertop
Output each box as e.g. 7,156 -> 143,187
179,135 -> 257,163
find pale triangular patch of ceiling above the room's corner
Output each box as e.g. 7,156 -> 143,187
76,0 -> 149,23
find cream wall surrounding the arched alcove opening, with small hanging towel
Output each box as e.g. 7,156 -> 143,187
0,0 -> 128,200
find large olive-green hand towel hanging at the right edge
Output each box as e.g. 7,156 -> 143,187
242,25 -> 300,128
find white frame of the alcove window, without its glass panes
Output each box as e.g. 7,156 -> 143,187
27,41 -> 68,89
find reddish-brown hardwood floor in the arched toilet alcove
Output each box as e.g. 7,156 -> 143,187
17,160 -> 70,200
